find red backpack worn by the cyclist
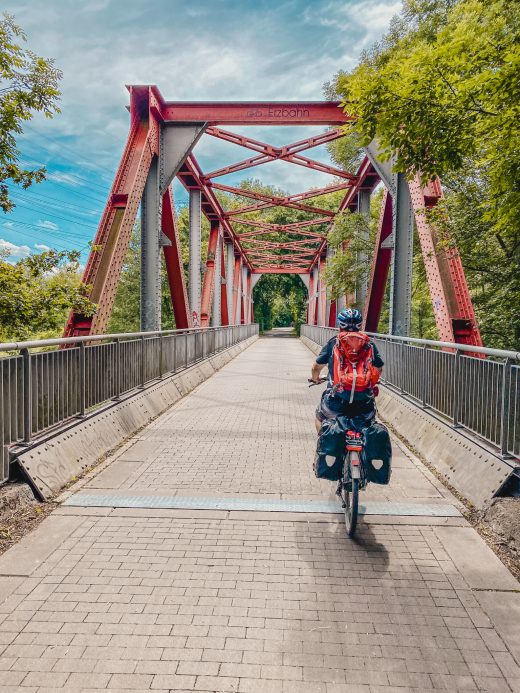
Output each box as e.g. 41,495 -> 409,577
333,332 -> 379,403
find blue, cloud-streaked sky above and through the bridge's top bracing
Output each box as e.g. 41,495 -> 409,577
0,0 -> 401,260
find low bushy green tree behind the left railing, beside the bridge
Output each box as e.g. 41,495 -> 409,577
0,250 -> 95,342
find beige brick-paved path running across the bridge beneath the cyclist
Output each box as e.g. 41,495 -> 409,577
0,338 -> 520,693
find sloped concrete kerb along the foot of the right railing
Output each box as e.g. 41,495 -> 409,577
301,337 -> 513,508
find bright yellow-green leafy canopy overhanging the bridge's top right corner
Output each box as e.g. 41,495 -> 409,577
335,0 -> 520,235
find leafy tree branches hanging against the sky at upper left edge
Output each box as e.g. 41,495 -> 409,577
0,13 -> 61,212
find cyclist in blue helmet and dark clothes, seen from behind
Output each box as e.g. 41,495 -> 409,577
311,308 -> 384,433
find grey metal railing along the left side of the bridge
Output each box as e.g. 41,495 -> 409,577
0,324 -> 258,482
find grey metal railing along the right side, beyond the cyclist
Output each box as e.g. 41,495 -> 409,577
301,325 -> 520,457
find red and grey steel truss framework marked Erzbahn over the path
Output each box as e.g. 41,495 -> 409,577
65,86 -> 481,346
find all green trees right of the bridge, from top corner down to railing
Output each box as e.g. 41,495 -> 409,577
326,0 -> 520,348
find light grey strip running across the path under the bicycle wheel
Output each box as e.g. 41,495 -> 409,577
64,493 -> 461,517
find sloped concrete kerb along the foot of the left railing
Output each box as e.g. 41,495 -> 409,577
16,335 -> 258,500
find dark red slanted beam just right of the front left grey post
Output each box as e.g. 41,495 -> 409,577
161,188 -> 192,330
